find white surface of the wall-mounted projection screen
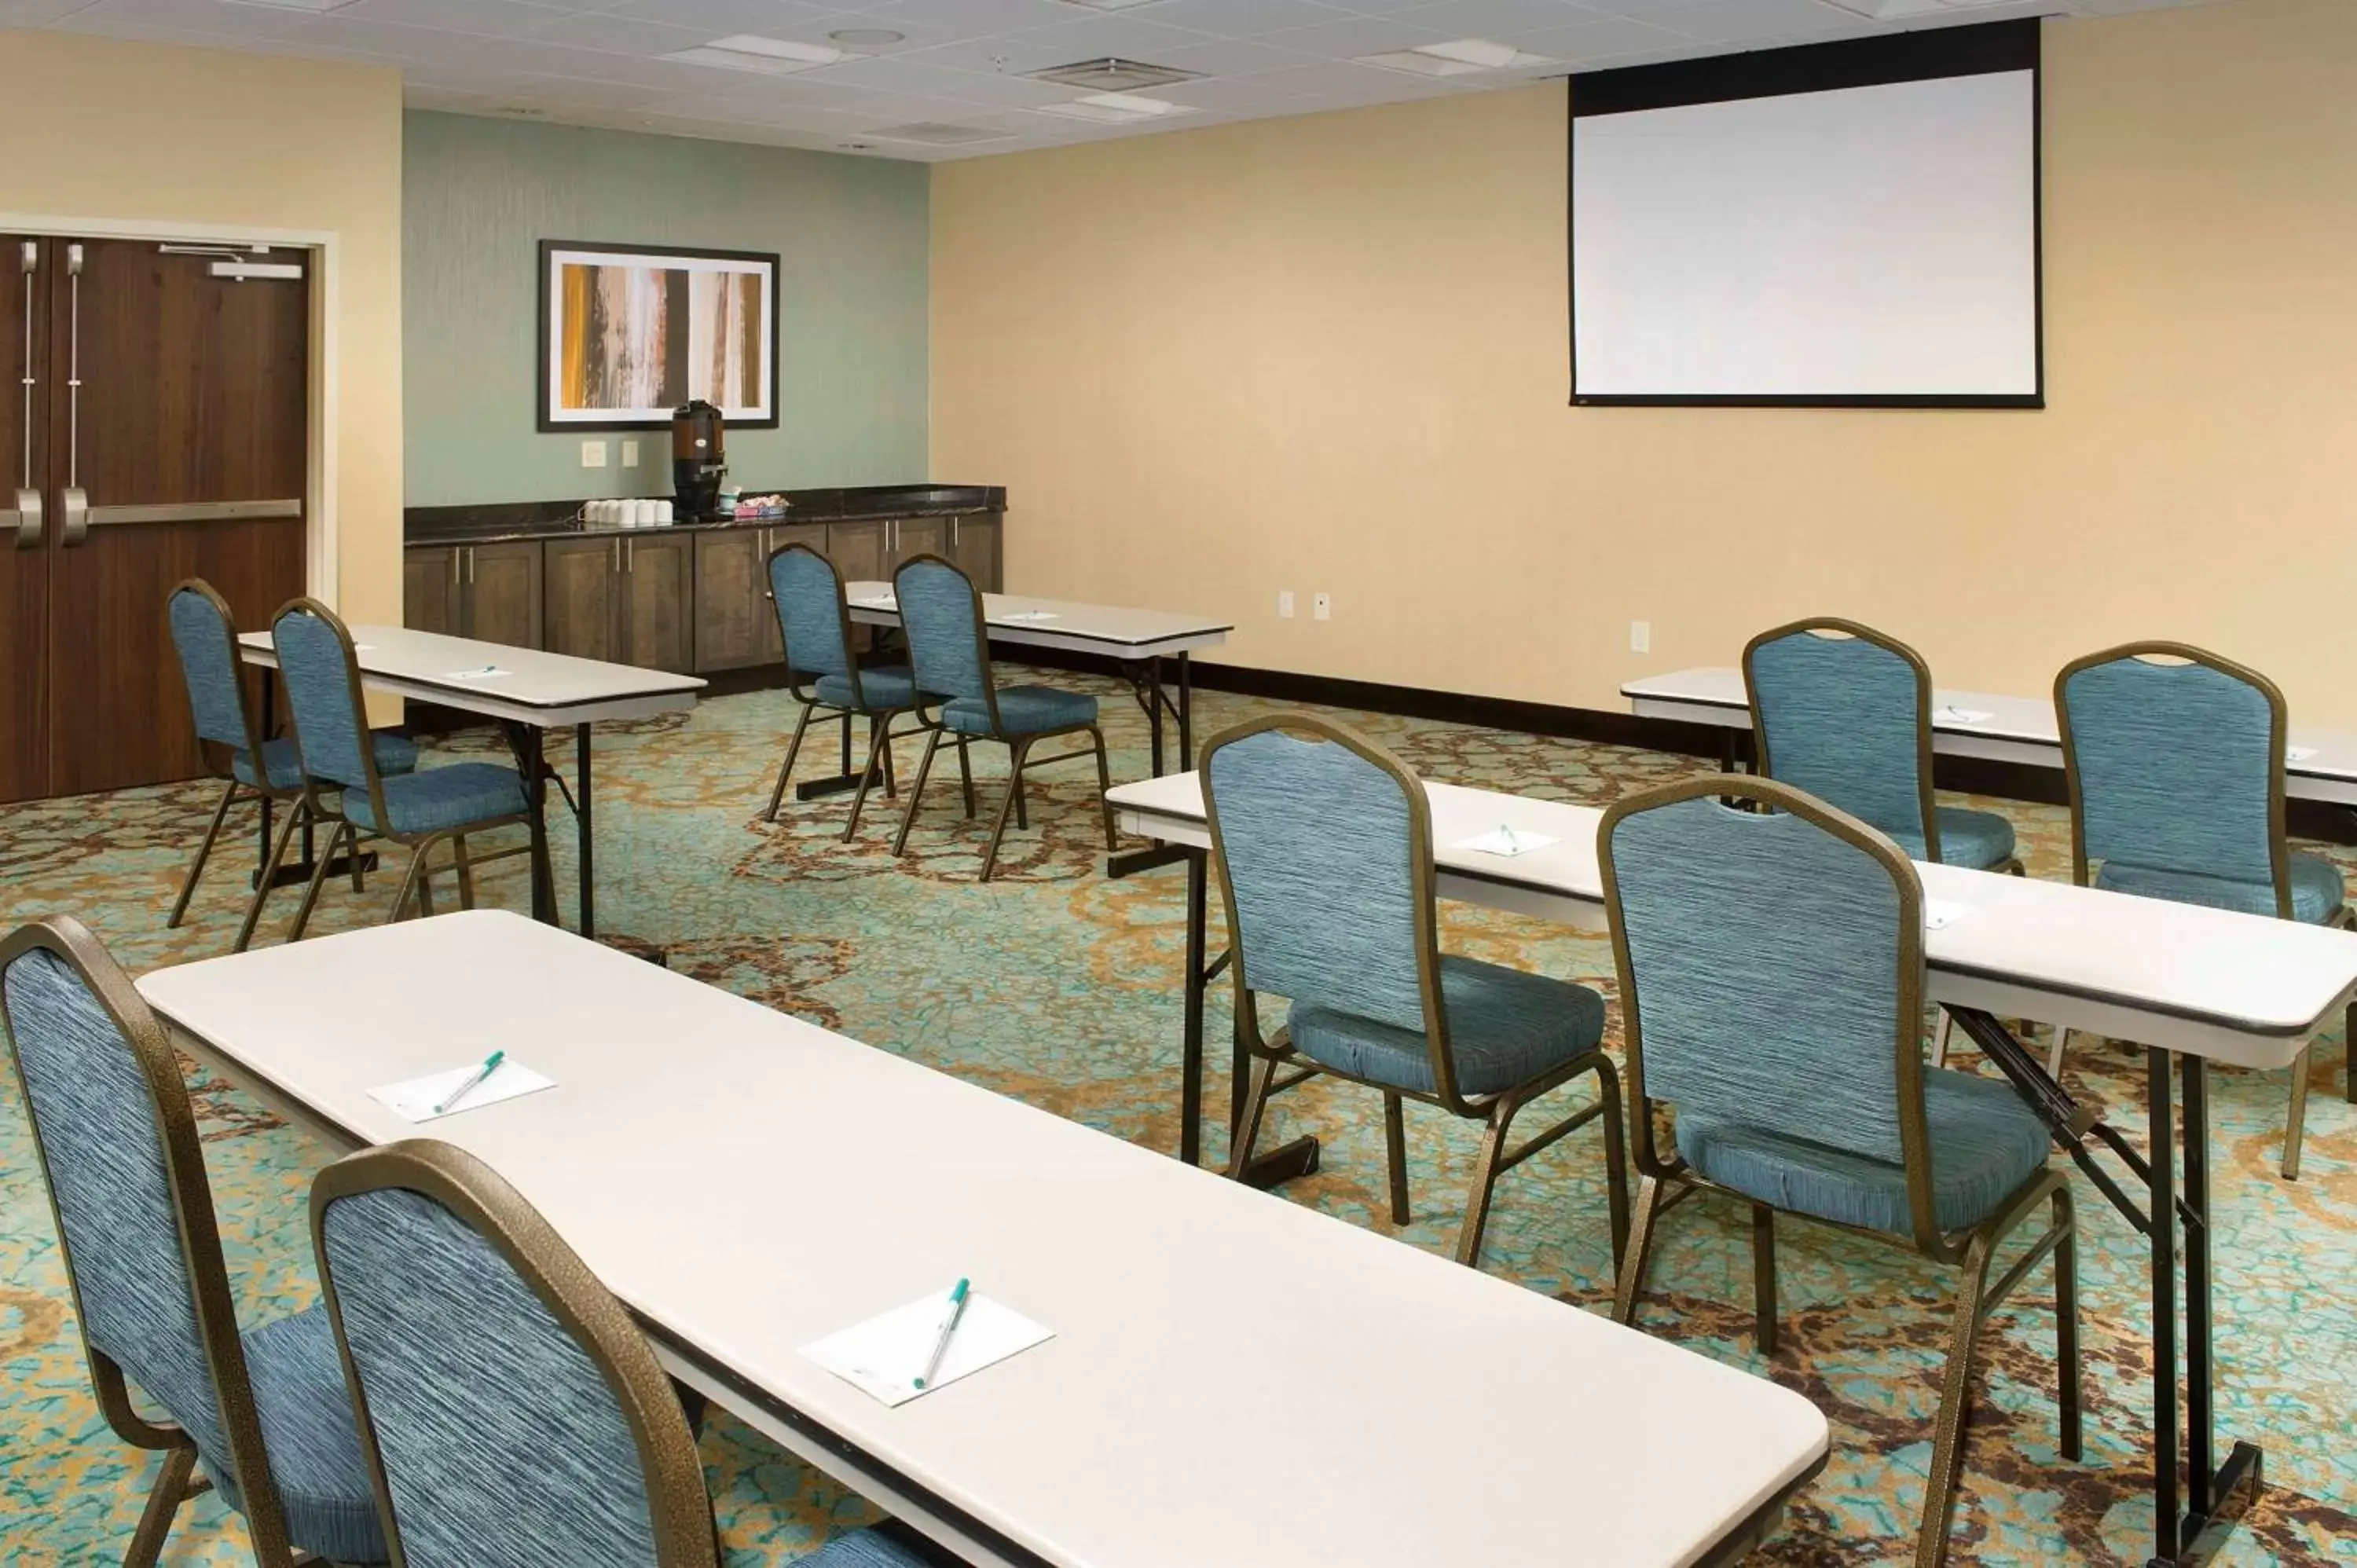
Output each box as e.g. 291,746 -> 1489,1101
1572,71 -> 2039,398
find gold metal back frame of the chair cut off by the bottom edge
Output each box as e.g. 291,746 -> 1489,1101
311,1139 -> 719,1568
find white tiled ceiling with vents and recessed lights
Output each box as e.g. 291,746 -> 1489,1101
0,0 -> 2201,160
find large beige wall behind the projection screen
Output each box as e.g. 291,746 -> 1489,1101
933,0 -> 2357,726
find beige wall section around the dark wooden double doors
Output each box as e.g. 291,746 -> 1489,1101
0,31 -> 401,636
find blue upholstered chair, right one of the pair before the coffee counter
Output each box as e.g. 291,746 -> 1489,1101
891,556 -> 1113,882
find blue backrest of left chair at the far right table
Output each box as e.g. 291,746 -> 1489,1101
1744,620 -> 1940,861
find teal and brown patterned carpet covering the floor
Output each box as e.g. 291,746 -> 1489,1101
0,676 -> 2357,1568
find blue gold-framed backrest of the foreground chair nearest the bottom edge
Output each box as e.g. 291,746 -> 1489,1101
311,1139 -> 714,1568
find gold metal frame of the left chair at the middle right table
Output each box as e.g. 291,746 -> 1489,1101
1200,712 -> 1629,1269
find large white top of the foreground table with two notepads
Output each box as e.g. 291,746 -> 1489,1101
139,910 -> 1827,1568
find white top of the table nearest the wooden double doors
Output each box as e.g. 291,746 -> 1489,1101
238,625 -> 705,726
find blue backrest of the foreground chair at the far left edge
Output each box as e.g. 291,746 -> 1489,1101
0,918 -> 288,1561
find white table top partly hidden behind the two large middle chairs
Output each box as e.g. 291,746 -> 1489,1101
1108,773 -> 2357,1068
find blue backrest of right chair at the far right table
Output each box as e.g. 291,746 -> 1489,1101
2055,641 -> 2291,915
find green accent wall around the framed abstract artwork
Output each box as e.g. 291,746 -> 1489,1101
401,111 -> 924,507
